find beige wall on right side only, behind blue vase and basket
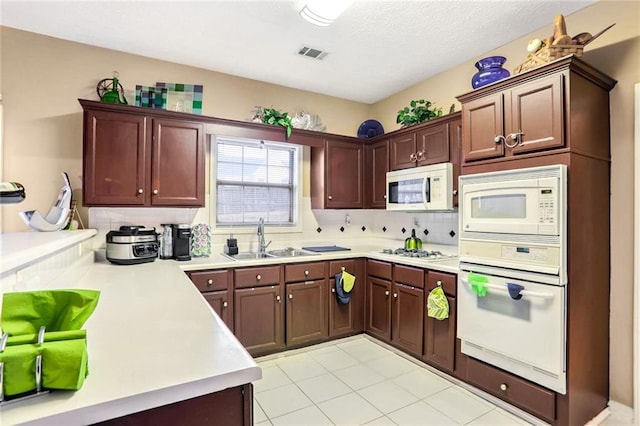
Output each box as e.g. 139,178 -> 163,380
372,1 -> 640,406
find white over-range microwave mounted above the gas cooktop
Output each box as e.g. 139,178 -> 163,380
386,163 -> 453,211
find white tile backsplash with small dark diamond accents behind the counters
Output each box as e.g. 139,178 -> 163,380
89,198 -> 458,251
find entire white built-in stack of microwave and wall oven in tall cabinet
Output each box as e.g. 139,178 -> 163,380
457,165 -> 568,394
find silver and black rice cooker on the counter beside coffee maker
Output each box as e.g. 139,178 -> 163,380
107,226 -> 159,265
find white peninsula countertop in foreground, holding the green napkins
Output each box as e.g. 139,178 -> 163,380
0,238 -> 262,425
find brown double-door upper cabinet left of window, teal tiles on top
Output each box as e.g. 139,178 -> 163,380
80,100 -> 205,207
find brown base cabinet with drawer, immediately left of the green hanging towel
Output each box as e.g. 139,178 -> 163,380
391,265 -> 424,356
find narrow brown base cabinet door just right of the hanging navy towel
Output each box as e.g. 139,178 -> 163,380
366,277 -> 391,342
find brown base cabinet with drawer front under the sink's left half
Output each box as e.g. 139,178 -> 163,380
233,266 -> 285,356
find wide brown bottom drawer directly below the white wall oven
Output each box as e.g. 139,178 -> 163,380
467,357 -> 556,422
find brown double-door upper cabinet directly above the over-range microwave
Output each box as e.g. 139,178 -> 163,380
389,113 -> 460,170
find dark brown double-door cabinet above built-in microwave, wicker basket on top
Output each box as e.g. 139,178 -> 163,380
458,55 -> 615,166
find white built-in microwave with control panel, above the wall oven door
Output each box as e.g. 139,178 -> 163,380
458,165 -> 567,284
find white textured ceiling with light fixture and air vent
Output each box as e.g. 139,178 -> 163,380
0,0 -> 597,103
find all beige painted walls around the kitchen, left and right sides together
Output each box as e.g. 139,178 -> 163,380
0,1 -> 640,406
